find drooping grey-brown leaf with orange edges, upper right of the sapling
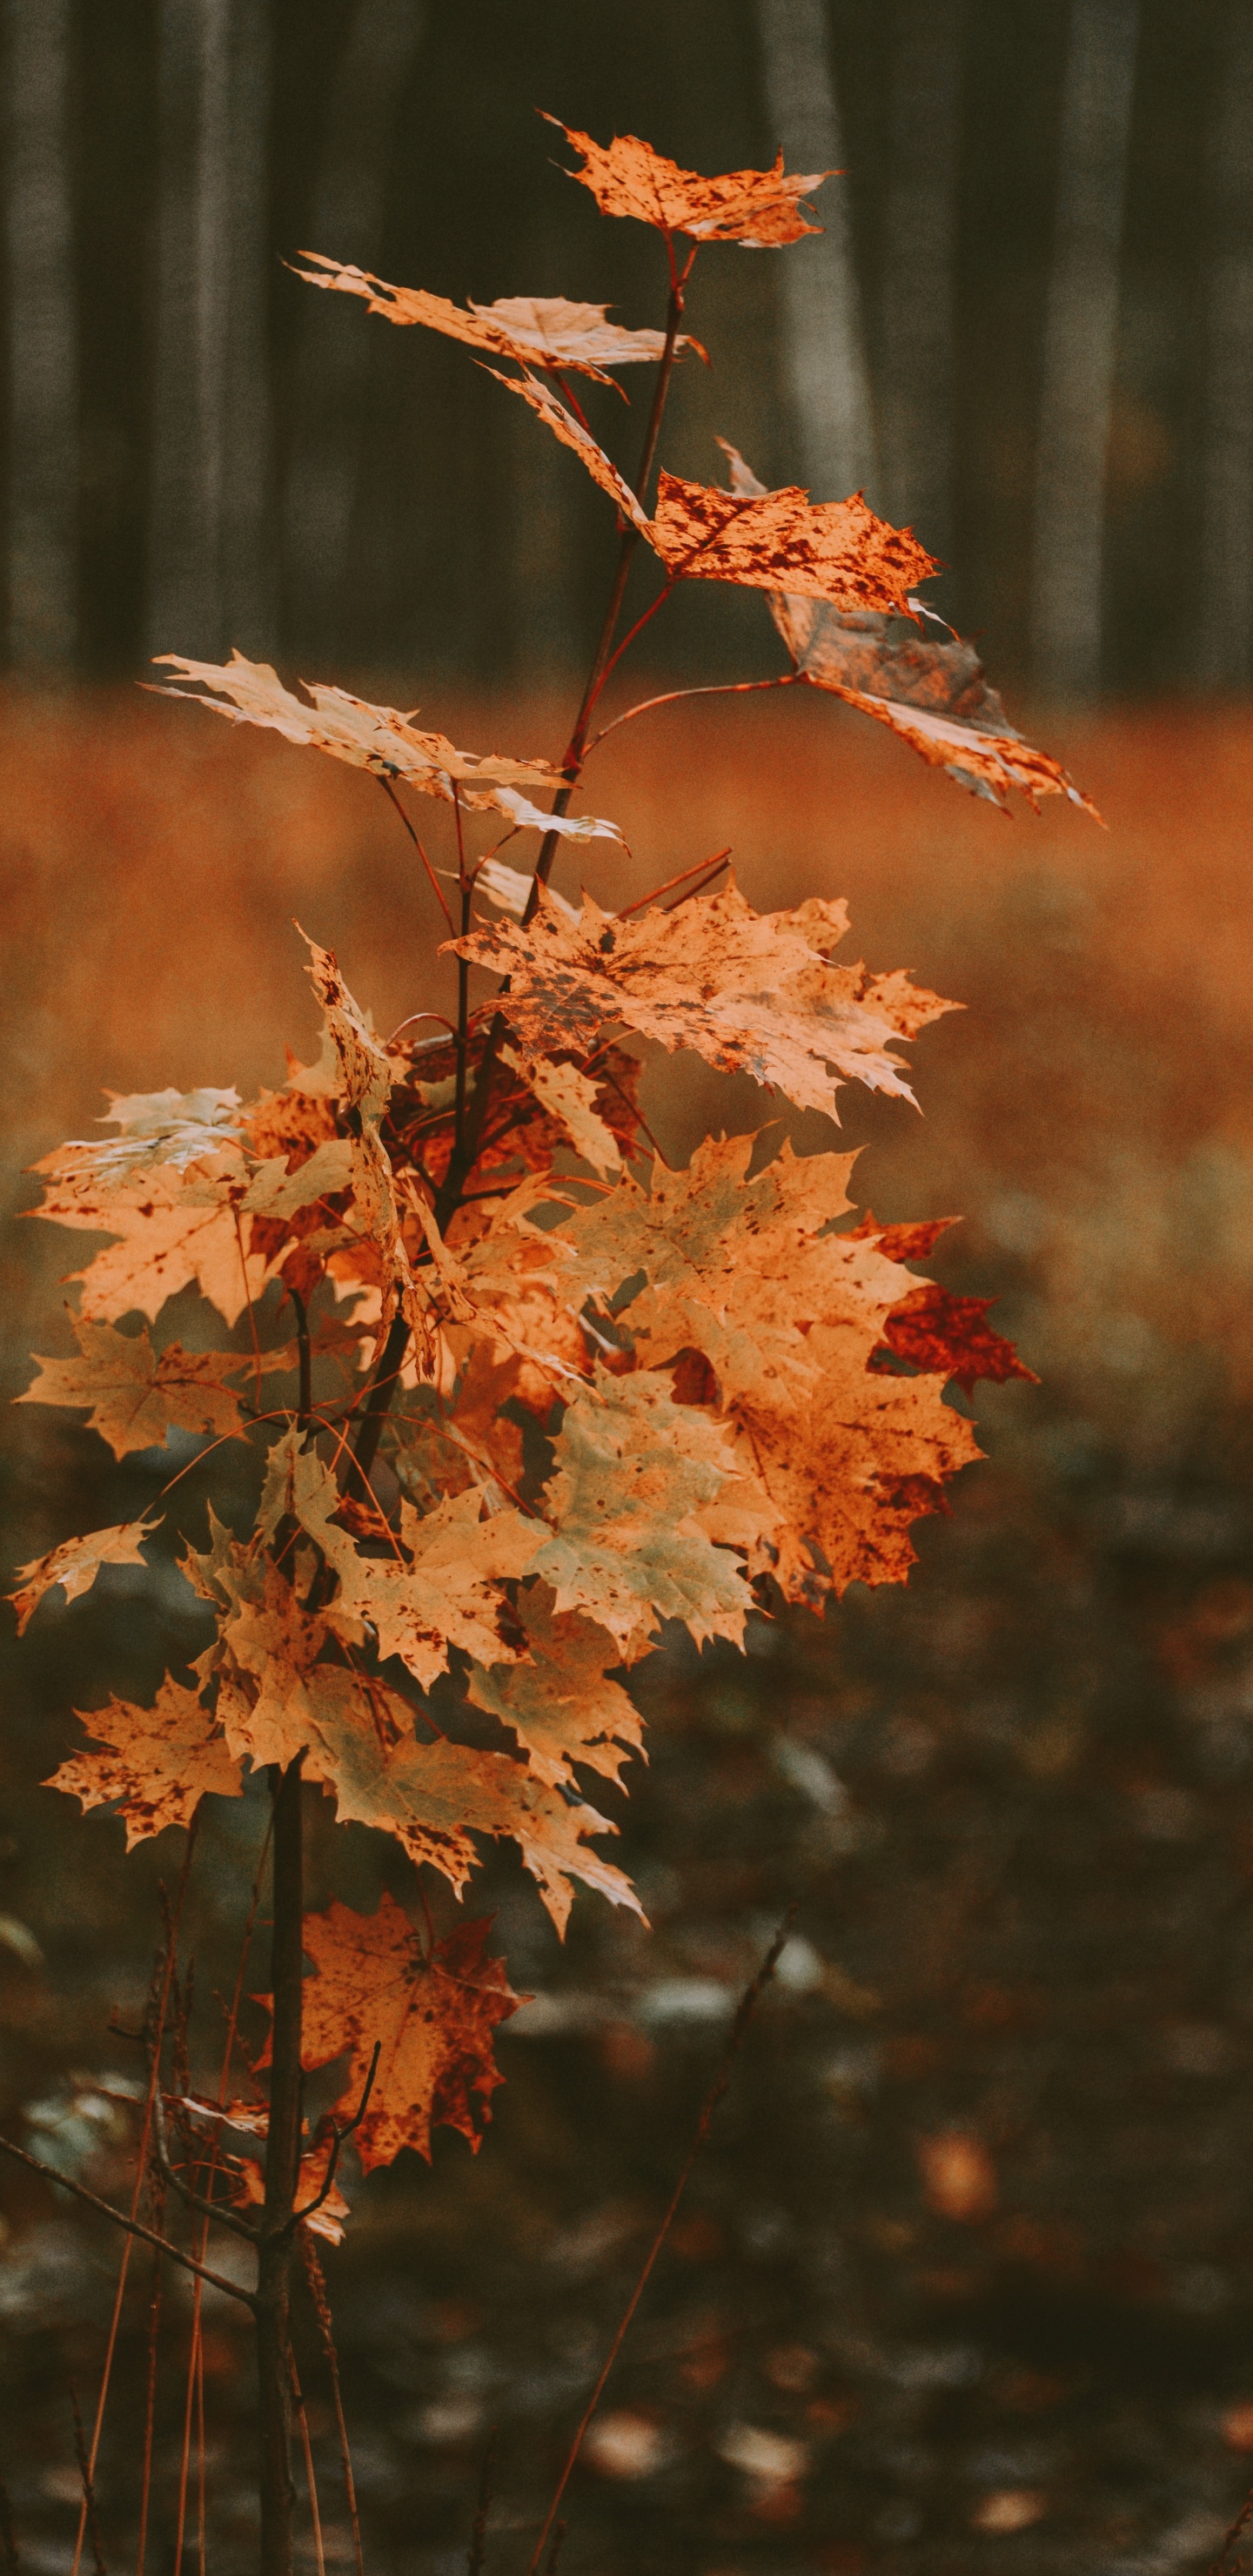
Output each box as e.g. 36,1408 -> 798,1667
720,438 -> 1101,822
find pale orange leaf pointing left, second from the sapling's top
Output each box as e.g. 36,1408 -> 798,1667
291,250 -> 707,384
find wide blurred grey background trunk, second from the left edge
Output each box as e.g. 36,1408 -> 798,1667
147,0 -> 273,662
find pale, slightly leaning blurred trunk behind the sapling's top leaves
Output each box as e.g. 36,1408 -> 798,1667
758,0 -> 876,502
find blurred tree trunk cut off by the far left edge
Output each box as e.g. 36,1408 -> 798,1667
3,0 -> 77,673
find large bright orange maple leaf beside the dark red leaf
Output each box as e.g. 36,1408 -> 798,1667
554,1136 -> 977,1600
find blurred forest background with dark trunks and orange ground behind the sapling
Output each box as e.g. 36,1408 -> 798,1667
12,15 -> 1253,2576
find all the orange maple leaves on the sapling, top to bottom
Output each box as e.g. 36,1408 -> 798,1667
16,116 -> 1078,2225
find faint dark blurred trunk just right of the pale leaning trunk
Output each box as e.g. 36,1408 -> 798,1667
879,0 -> 962,559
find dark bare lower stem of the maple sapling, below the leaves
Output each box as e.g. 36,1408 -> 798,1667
258,1757 -> 305,2576
